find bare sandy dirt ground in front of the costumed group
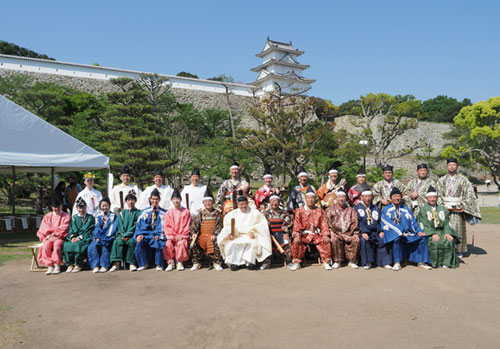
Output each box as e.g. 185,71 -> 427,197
0,224 -> 500,348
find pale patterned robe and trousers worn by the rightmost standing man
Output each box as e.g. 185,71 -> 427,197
438,174 -> 481,253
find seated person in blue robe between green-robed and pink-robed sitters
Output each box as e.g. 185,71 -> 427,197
134,188 -> 167,271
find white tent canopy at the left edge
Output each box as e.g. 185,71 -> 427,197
0,95 -> 109,172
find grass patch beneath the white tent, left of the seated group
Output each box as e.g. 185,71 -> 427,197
0,231 -> 39,266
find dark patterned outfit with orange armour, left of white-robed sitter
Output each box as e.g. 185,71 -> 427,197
189,208 -> 223,263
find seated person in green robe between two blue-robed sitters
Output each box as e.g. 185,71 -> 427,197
109,193 -> 141,273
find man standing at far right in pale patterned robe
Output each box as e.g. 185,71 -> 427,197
438,158 -> 481,258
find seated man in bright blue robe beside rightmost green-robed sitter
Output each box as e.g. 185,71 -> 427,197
381,187 -> 432,271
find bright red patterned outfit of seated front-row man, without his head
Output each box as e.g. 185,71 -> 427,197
292,206 -> 331,263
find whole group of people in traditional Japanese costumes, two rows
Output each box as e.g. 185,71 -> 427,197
37,159 -> 481,275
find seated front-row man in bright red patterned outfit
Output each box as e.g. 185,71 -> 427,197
290,187 -> 332,271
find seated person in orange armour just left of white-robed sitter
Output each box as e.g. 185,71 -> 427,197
190,188 -> 223,271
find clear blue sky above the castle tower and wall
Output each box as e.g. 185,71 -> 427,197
0,0 -> 500,105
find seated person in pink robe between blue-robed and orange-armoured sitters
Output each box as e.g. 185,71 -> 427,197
163,189 -> 191,271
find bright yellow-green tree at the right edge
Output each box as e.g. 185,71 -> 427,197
442,97 -> 500,187
